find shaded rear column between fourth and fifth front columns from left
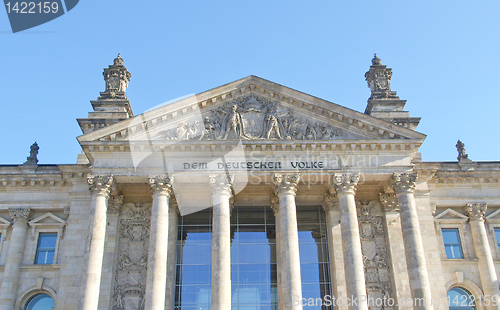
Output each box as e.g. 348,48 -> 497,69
323,194 -> 348,310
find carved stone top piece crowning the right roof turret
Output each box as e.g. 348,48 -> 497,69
365,54 -> 397,99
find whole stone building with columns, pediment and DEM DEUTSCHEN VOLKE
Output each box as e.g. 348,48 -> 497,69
0,55 -> 500,310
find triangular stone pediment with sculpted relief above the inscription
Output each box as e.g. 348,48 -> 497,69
78,76 -> 425,146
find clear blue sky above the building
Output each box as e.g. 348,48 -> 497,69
0,0 -> 500,164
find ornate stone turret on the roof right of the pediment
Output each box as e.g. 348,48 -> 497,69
365,54 -> 420,130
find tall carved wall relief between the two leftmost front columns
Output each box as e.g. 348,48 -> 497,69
112,203 -> 151,310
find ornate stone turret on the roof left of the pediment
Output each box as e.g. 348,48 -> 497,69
78,54 -> 134,133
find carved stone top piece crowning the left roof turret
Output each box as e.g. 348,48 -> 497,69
99,54 -> 132,100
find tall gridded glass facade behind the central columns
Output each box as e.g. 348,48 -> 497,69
175,207 -> 331,310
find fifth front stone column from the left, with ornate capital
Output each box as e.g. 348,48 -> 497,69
332,173 -> 368,310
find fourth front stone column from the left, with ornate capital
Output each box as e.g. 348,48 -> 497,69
273,174 -> 302,310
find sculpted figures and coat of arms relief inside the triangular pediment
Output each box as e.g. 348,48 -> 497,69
155,95 -> 343,140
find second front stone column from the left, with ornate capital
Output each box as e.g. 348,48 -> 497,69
144,175 -> 173,310
